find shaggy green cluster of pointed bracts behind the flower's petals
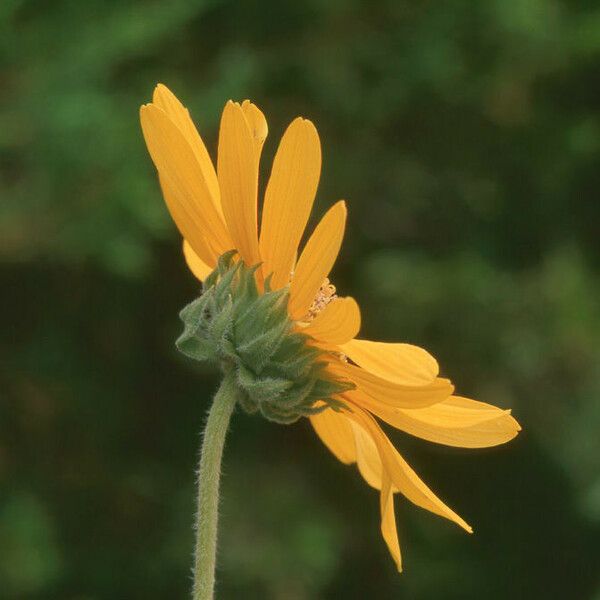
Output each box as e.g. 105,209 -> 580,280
176,251 -> 354,423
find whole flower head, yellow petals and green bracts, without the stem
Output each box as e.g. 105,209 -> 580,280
140,85 -> 520,570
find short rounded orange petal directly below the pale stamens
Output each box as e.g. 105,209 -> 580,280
302,296 -> 360,347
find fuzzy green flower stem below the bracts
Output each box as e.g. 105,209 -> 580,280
192,370 -> 237,600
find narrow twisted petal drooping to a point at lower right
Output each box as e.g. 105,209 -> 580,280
348,402 -> 473,533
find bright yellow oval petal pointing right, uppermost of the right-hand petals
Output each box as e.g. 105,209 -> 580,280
340,340 -> 439,385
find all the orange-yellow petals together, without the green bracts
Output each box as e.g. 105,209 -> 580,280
140,85 -> 520,570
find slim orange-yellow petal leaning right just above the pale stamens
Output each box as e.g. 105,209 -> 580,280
288,200 -> 347,320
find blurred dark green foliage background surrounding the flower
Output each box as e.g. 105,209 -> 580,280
0,0 -> 600,600
